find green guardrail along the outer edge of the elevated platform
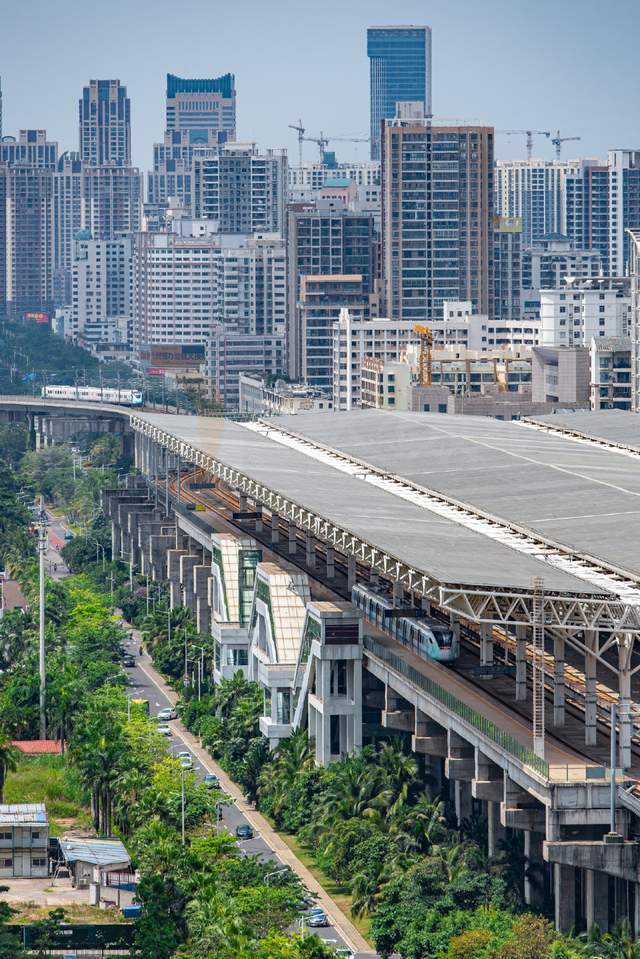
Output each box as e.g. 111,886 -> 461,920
363,636 -> 549,780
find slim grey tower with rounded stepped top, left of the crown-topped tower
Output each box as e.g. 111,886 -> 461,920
78,80 -> 131,166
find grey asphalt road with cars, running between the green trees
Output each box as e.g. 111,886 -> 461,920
46,514 -> 375,959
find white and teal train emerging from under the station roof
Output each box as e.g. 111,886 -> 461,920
351,583 -> 460,663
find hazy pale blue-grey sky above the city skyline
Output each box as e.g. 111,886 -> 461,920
0,0 -> 640,170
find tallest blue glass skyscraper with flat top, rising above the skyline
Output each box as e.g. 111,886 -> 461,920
367,26 -> 432,160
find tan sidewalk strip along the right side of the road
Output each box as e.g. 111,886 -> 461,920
133,630 -> 376,957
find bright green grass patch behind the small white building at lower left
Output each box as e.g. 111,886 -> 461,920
4,756 -> 91,836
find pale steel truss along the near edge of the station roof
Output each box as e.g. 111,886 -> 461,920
130,413 -> 640,640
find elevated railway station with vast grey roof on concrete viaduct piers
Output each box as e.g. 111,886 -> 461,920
0,400 -> 640,934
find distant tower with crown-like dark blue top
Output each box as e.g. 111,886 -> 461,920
166,73 -> 236,144
